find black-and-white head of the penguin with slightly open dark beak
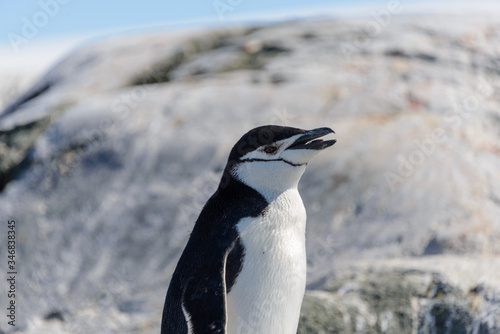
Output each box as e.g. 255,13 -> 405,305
225,125 -> 336,195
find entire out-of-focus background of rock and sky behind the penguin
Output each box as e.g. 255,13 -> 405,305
0,0 -> 500,334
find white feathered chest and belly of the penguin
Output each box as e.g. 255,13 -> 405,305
227,189 -> 307,334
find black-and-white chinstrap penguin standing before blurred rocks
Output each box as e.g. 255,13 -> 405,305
161,125 -> 336,334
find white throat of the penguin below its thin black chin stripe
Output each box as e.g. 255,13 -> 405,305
225,162 -> 306,203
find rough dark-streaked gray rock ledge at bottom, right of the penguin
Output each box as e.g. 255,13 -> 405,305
298,268 -> 500,334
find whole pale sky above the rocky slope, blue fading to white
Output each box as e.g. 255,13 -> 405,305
0,0 -> 498,73
